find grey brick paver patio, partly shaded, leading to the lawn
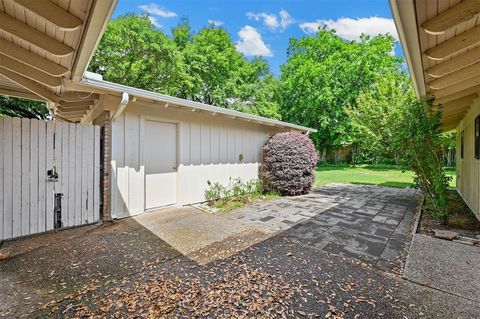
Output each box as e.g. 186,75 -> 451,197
227,184 -> 418,268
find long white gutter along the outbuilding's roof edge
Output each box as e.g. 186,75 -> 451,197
79,72 -> 317,132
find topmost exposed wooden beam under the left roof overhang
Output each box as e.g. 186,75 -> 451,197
14,0 -> 83,31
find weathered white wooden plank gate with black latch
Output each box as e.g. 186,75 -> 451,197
0,117 -> 100,240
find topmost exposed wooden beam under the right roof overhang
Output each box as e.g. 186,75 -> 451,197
422,0 -> 480,35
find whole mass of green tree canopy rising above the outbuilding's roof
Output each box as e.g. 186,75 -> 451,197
90,14 -> 280,118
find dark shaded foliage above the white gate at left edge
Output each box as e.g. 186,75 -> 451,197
0,96 -> 49,119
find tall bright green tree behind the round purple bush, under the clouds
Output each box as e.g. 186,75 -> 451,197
281,28 -> 399,159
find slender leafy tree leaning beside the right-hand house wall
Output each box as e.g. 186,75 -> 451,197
352,73 -> 449,221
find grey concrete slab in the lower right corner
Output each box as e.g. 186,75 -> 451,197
404,234 -> 480,301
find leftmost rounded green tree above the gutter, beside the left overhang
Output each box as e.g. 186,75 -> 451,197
89,14 -> 189,94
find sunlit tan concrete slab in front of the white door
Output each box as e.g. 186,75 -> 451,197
134,207 -> 248,255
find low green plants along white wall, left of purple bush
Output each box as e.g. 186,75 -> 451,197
205,178 -> 278,211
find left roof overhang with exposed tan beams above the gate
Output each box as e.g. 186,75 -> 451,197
0,0 -> 117,120
